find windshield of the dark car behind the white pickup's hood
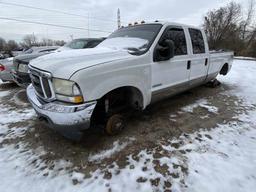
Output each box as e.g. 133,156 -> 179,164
56,38 -> 106,52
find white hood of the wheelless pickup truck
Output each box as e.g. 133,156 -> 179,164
30,47 -> 134,79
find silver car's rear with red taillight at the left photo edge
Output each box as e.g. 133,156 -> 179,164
0,57 -> 13,82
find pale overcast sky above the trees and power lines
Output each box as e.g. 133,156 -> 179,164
0,0 -> 248,41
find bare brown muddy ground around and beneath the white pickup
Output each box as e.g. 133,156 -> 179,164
0,80 -> 244,188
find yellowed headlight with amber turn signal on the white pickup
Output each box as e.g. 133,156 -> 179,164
52,78 -> 84,103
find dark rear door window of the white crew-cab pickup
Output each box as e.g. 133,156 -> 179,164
189,29 -> 205,54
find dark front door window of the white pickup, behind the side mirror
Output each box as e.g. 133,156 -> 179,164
167,28 -> 187,56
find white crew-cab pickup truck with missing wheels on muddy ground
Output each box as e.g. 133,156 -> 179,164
27,22 -> 233,138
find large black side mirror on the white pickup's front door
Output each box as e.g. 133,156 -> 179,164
154,39 -> 174,62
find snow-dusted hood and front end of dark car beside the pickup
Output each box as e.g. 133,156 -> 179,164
12,46 -> 59,87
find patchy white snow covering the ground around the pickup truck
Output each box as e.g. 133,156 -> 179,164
0,60 -> 256,192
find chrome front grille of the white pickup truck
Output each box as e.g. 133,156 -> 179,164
29,66 -> 54,101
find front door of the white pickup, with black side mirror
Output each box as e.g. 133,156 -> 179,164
152,26 -> 190,101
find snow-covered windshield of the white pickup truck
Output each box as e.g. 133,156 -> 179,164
99,24 -> 162,54
